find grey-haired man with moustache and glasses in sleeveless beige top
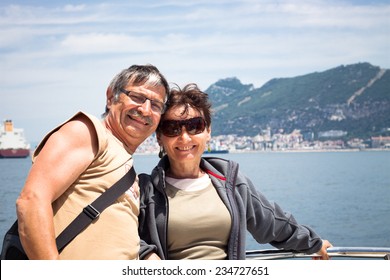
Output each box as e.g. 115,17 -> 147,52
16,65 -> 169,260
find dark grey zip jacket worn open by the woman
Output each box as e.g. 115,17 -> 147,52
139,156 -> 322,260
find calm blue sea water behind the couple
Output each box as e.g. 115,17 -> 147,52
0,151 -> 390,250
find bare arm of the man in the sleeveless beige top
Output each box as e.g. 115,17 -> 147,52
16,116 -> 98,259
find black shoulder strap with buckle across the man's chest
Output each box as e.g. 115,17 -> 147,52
56,167 -> 136,252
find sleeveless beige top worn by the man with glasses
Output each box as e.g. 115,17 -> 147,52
33,112 -> 140,260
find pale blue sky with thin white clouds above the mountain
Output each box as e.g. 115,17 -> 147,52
0,0 -> 390,142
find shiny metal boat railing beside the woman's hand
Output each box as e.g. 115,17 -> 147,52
246,247 -> 390,260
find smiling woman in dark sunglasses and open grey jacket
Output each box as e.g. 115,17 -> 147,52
139,84 -> 331,260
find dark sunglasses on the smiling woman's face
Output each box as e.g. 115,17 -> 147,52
158,117 -> 206,137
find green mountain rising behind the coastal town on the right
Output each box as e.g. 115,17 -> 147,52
206,63 -> 390,139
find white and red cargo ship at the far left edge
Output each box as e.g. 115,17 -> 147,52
0,120 -> 30,158
